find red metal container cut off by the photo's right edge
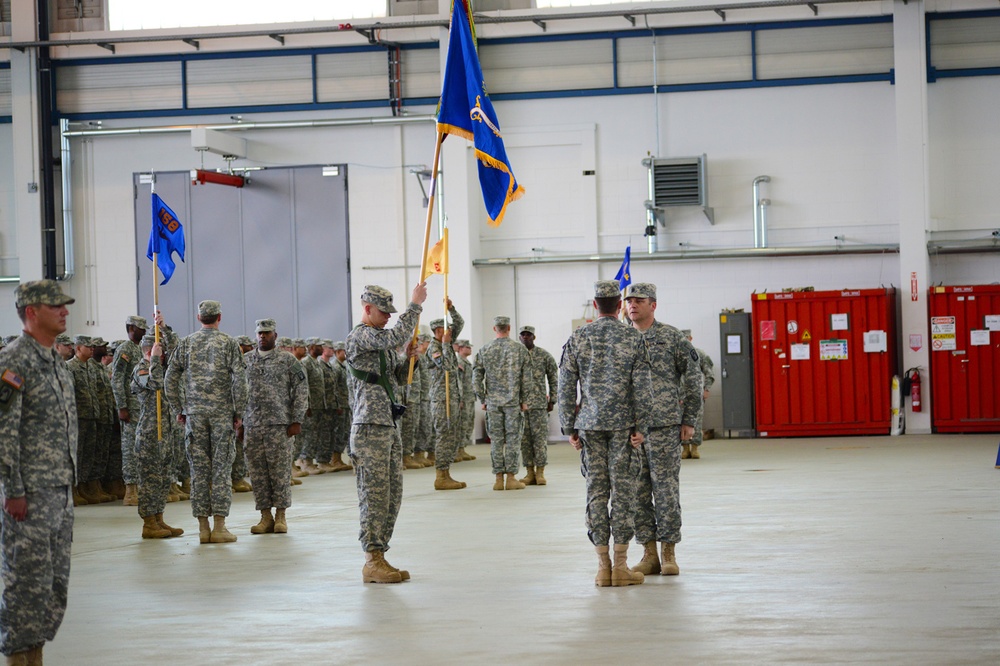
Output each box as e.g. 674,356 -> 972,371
928,284 -> 1000,432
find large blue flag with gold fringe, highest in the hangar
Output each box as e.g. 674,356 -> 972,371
437,0 -> 524,227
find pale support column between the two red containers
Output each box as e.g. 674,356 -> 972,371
893,0 -> 931,433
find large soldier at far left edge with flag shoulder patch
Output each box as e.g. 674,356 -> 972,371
0,280 -> 77,664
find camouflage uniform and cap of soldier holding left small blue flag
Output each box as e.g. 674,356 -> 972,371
130,350 -> 173,518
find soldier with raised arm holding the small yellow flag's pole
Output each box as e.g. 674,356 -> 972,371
424,298 -> 466,490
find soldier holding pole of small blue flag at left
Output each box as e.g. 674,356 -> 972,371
130,333 -> 184,539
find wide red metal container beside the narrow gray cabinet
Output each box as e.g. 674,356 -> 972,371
752,289 -> 896,437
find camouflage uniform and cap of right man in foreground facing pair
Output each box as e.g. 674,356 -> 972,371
629,306 -> 701,544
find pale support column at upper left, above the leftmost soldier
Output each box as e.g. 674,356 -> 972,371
10,0 -> 43,281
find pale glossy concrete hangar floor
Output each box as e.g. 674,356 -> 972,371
45,435 -> 1000,666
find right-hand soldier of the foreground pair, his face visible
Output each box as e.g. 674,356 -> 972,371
625,282 -> 701,576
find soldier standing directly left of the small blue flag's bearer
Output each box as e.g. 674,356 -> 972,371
111,315 -> 149,506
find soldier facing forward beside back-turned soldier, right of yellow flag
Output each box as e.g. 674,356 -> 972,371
518,326 -> 559,486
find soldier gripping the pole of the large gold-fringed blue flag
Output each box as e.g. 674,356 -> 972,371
346,282 -> 427,583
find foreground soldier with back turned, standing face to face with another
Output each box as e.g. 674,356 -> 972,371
558,280 -> 652,587
